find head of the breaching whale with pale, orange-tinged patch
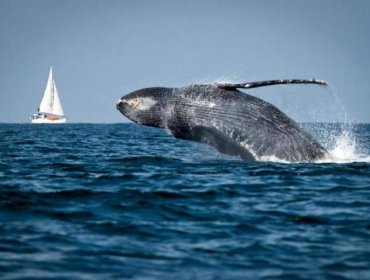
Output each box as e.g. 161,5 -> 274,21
116,87 -> 173,127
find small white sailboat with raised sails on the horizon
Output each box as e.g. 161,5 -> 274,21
31,67 -> 67,123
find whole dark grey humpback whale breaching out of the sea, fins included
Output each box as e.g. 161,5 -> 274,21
116,79 -> 327,162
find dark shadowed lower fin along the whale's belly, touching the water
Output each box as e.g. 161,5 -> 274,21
171,126 -> 256,161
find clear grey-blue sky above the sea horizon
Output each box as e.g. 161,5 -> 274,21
0,0 -> 370,123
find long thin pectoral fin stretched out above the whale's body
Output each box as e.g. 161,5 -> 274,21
216,79 -> 328,90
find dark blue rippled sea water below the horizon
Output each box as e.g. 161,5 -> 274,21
0,124 -> 370,279
